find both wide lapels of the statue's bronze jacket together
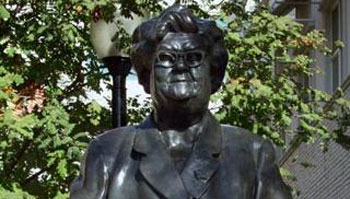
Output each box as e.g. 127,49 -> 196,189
134,112 -> 222,199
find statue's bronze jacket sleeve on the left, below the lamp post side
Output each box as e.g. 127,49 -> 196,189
70,139 -> 108,199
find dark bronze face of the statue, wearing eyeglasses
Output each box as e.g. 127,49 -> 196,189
151,33 -> 211,109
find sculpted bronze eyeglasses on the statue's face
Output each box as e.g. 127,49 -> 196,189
156,50 -> 205,68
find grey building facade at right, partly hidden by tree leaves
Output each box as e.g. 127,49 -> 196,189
269,0 -> 350,199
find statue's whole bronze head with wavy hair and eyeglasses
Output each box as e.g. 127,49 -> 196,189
131,4 -> 228,112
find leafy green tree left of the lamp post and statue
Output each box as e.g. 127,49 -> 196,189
0,1 -> 114,198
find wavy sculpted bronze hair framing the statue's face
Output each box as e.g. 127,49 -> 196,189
131,4 -> 228,93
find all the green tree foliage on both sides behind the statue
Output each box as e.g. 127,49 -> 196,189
0,0 -> 350,199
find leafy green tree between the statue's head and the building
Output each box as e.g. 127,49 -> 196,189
217,1 -> 350,150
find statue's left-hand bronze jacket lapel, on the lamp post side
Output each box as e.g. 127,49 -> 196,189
134,116 -> 188,199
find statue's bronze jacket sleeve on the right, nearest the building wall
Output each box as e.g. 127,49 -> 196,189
255,141 -> 292,199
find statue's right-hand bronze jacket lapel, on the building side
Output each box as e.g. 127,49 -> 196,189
181,113 -> 222,198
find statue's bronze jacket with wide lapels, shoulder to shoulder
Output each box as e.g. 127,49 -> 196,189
71,112 -> 290,199
